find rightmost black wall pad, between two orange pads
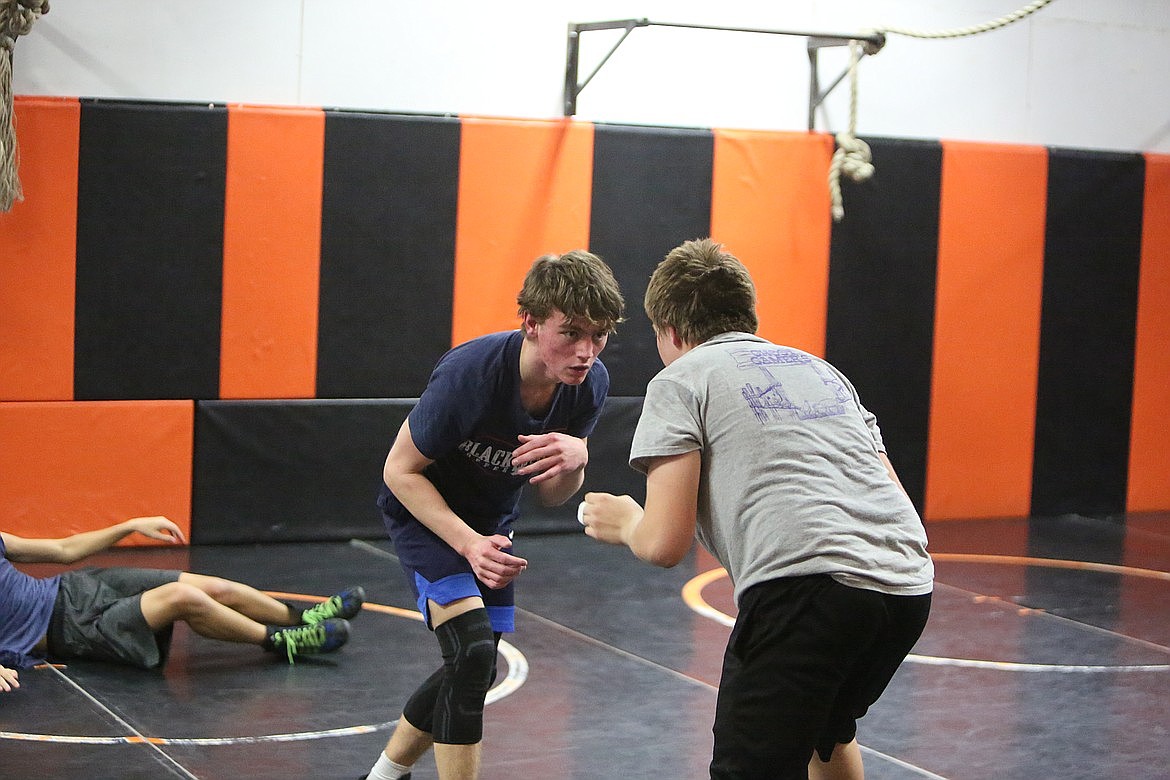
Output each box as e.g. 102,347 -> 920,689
1031,150 -> 1145,517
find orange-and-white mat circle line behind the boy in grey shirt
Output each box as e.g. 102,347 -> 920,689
682,552 -> 1170,672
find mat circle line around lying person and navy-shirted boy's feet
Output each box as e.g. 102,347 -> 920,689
0,591 -> 528,747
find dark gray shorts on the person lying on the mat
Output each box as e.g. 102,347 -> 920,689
48,567 -> 181,669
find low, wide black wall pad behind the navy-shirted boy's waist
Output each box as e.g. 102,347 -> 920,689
191,398 -> 646,544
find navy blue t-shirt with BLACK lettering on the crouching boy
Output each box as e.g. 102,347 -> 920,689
378,330 -> 610,561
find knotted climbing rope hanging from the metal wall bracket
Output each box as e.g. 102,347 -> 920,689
828,0 -> 1052,222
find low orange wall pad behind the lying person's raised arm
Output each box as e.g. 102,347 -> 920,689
0,401 -> 194,544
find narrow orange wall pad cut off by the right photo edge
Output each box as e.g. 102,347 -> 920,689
1127,154 -> 1170,512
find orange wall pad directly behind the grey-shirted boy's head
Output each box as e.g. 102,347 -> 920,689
711,130 -> 833,356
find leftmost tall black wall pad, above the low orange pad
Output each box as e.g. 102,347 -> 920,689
74,101 -> 227,400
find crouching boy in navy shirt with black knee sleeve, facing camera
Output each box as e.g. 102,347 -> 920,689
367,250 -> 625,780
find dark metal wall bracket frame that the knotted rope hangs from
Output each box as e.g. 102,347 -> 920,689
565,19 -> 886,130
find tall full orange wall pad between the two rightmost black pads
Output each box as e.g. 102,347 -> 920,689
924,141 -> 1048,519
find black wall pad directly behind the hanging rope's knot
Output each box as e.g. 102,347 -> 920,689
825,139 -> 942,512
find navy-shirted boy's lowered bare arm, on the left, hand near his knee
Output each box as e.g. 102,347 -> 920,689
381,420 -> 528,588
